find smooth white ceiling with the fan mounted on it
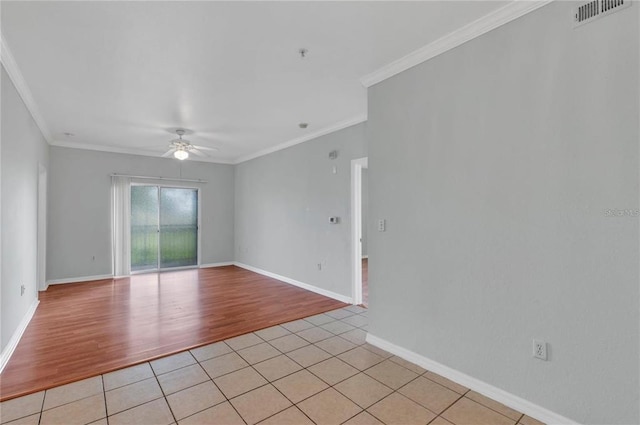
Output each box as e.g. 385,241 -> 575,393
1,1 -> 505,162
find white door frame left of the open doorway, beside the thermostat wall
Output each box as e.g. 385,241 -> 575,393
351,157 -> 369,305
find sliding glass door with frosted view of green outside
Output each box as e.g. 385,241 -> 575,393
131,185 -> 198,272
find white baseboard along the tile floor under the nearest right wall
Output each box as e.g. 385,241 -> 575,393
367,333 -> 578,425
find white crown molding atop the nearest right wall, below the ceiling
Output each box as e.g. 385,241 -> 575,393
360,0 -> 552,88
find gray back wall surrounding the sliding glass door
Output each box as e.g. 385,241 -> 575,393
47,147 -> 234,280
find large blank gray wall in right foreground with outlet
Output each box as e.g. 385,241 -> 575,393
367,2 -> 640,424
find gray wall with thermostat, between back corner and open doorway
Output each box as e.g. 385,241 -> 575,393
235,124 -> 366,297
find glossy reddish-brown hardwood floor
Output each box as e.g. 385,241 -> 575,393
0,266 -> 346,401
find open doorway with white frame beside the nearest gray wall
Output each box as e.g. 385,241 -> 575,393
351,158 -> 369,306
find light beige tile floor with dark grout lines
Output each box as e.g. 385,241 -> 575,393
0,306 -> 541,425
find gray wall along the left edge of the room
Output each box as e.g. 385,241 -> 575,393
0,67 -> 49,350
